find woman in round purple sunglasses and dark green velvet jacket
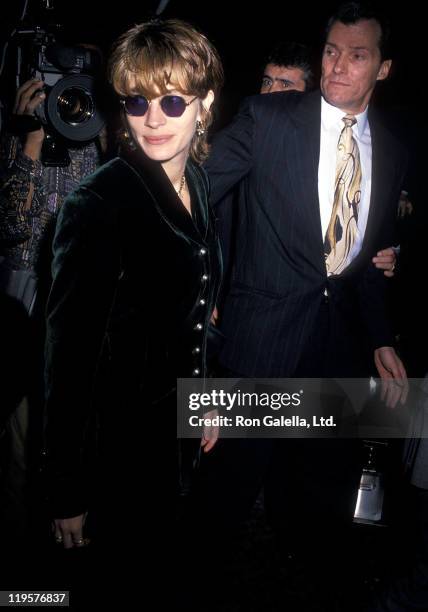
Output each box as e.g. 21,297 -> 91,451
46,20 -> 223,576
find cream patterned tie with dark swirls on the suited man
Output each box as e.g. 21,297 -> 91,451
324,115 -> 361,275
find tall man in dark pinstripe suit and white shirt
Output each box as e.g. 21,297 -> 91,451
196,2 -> 406,592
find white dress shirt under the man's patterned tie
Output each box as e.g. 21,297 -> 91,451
318,98 -> 372,265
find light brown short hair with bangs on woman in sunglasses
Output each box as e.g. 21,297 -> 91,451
109,19 -> 223,163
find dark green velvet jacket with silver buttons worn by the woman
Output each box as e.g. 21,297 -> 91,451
46,149 -> 221,518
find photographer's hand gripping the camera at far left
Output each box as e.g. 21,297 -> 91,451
13,79 -> 46,160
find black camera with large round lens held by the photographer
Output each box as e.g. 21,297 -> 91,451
18,27 -> 104,143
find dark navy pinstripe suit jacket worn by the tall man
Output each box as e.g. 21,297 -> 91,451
206,92 -> 406,377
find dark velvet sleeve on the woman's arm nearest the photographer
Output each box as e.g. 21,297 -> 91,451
46,187 -> 120,518
